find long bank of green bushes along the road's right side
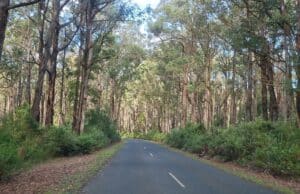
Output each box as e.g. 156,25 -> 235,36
165,120 -> 300,176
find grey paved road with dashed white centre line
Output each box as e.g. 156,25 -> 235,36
82,140 -> 275,194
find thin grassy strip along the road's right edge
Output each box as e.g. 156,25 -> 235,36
157,141 -> 296,194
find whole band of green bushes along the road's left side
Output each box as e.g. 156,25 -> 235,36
0,106 -> 120,178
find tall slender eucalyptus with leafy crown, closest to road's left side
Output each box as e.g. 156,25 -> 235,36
72,0 -> 132,134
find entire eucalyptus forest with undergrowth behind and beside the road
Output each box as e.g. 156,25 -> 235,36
0,0 -> 300,186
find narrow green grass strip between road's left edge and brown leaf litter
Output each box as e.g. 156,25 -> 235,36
46,142 -> 124,194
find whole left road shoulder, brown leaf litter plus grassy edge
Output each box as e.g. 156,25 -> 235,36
0,142 -> 123,193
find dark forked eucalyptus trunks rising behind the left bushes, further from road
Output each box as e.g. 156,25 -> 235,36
31,0 -> 76,125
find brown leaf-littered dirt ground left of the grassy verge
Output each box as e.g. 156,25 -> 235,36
0,153 -> 97,194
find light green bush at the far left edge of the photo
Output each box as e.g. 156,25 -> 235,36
0,106 -> 49,178
